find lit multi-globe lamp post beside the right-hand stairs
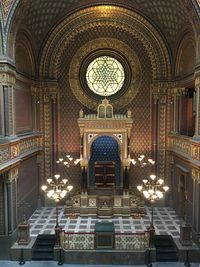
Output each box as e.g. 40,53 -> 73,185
137,174 -> 169,246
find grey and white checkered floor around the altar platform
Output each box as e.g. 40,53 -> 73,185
29,206 -> 182,238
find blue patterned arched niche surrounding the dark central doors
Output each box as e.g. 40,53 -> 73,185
89,135 -> 121,188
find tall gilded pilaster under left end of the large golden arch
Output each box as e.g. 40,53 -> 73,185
42,82 -> 58,182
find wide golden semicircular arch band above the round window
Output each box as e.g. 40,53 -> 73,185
39,6 -> 171,79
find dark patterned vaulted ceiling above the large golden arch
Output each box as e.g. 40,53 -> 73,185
2,0 -> 199,59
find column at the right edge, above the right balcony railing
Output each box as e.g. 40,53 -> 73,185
193,76 -> 200,140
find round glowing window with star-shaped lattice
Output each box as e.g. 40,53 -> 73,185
86,56 -> 125,96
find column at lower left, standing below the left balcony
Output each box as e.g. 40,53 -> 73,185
6,167 -> 18,233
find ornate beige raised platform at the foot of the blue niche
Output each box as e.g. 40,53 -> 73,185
64,193 -> 144,218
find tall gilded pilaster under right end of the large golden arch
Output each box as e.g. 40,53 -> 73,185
152,82 -> 169,181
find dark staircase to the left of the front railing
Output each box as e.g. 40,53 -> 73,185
32,235 -> 55,260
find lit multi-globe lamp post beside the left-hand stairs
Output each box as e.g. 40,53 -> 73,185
41,174 -> 73,245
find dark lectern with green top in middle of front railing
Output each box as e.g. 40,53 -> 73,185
95,222 -> 115,249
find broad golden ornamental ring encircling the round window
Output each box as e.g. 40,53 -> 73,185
69,38 -> 141,109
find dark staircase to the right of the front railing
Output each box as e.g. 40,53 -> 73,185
154,235 -> 178,261
